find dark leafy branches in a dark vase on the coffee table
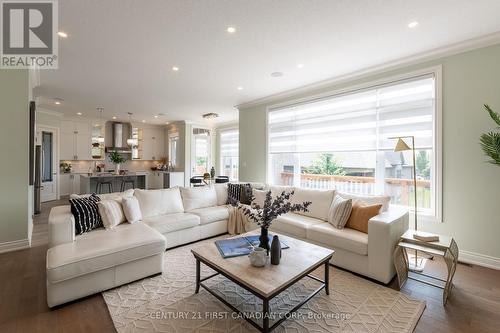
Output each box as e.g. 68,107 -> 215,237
238,191 -> 311,254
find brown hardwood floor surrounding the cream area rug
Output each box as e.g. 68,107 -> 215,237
0,199 -> 500,333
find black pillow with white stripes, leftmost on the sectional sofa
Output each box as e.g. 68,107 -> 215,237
69,193 -> 103,235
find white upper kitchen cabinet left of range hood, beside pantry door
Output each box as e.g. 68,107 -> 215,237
60,120 -> 92,160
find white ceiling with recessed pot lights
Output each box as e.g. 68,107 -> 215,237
36,0 -> 500,124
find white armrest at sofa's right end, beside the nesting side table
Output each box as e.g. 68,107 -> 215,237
368,206 -> 409,283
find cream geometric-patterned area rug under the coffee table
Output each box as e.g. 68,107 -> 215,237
103,235 -> 425,333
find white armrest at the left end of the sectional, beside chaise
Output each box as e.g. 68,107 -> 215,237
49,205 -> 75,248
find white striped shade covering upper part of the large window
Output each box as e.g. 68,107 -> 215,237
268,76 -> 435,154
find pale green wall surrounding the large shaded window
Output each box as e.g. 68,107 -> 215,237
239,45 -> 500,258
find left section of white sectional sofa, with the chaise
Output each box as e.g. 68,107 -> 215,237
47,187 -> 229,307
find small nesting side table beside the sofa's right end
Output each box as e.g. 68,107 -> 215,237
394,230 -> 458,305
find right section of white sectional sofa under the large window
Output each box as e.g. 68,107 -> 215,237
245,186 -> 408,283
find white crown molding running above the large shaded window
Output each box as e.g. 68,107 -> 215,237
235,31 -> 500,110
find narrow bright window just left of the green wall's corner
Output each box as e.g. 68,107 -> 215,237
219,128 -> 239,181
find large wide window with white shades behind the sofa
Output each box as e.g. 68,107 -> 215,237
268,73 -> 439,216
